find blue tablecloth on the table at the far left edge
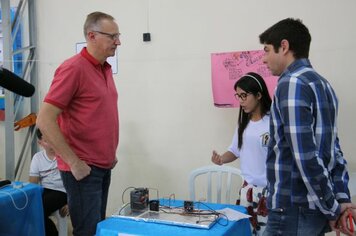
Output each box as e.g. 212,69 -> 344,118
0,182 -> 45,236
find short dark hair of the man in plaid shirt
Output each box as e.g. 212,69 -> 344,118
259,18 -> 311,59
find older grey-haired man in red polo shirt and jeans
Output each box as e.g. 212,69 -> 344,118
37,12 -> 121,236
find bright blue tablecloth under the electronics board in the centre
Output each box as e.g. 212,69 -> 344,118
96,199 -> 251,236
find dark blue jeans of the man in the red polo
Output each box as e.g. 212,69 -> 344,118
61,166 -> 111,236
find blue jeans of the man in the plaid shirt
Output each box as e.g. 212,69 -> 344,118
263,207 -> 330,236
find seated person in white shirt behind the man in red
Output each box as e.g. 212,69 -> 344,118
29,129 -> 69,236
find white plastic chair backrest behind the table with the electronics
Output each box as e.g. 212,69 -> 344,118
189,165 -> 244,204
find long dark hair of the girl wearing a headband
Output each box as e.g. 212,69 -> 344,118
234,72 -> 272,149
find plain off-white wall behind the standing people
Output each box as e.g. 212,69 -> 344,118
32,0 -> 356,214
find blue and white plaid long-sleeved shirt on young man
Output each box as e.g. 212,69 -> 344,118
267,59 -> 350,220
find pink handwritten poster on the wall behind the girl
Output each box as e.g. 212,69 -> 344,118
211,50 -> 278,107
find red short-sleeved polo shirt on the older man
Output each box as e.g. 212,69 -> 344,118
44,48 -> 119,171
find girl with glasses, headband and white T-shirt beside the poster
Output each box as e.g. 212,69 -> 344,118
211,72 -> 272,235
